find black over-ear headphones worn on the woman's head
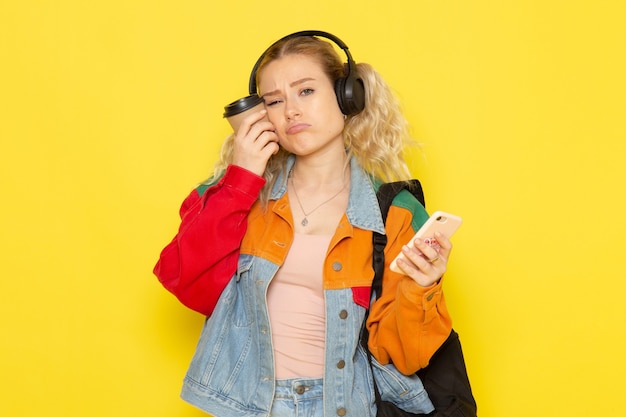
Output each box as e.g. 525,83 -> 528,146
248,30 -> 365,116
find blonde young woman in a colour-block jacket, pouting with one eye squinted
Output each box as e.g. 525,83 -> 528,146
155,31 -> 452,417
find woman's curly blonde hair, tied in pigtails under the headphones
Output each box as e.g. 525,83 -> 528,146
208,36 -> 415,203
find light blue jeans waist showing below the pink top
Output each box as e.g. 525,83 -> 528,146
271,378 -> 324,417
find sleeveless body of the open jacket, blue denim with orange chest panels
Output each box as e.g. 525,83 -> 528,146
181,158 -> 433,417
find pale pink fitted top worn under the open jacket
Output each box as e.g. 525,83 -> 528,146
267,233 -> 332,379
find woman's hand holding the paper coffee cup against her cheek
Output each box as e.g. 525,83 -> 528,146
233,110 -> 279,176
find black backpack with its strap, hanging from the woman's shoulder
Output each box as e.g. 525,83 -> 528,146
361,179 -> 477,417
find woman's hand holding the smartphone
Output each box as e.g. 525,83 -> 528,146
397,232 -> 452,287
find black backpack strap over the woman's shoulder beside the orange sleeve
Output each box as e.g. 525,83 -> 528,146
372,179 -> 426,299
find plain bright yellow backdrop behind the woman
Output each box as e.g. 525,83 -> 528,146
0,0 -> 626,417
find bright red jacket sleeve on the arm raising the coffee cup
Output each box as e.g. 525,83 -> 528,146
154,165 -> 265,316
